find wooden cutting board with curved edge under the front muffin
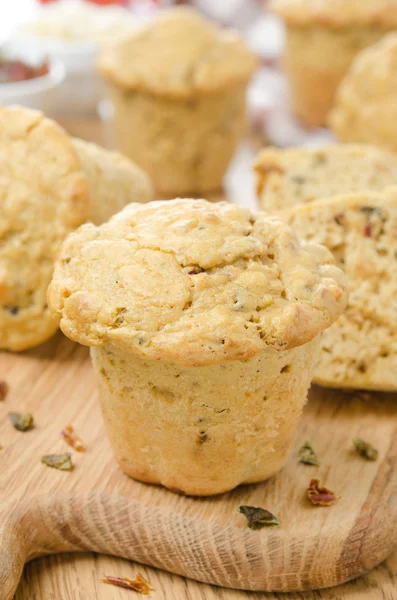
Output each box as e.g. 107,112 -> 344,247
0,334 -> 397,600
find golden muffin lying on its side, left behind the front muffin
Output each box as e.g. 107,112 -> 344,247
0,107 -> 151,350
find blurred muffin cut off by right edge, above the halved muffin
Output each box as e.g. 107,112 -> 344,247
330,33 -> 397,152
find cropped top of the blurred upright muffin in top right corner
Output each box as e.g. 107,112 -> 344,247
270,0 -> 397,29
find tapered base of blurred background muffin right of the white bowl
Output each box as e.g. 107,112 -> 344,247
106,84 -> 246,199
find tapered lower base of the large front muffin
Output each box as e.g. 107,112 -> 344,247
91,340 -> 318,495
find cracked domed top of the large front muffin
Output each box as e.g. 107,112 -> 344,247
48,199 -> 346,366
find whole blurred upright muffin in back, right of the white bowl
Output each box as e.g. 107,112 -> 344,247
99,8 -> 256,197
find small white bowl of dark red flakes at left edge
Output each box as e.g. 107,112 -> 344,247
0,55 -> 66,114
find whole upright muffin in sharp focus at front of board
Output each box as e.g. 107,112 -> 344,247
48,199 -> 346,495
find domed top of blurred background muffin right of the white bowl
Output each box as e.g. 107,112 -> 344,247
99,8 -> 257,98
